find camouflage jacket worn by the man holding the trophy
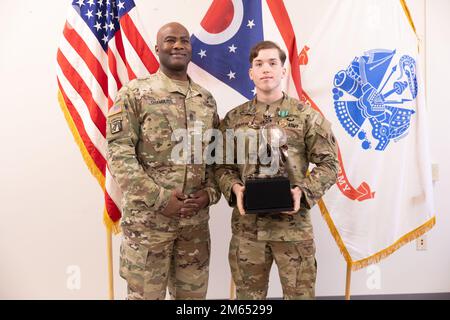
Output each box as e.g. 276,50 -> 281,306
216,94 -> 339,241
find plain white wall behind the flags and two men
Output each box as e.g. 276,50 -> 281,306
0,0 -> 450,299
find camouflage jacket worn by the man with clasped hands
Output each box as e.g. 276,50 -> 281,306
107,70 -> 220,231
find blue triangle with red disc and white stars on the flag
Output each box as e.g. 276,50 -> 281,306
191,1 -> 264,99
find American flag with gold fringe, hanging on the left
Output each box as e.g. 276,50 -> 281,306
57,0 -> 158,231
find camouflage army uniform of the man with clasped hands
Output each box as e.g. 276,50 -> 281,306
107,70 -> 220,299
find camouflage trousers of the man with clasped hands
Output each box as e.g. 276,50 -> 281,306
120,223 -> 210,300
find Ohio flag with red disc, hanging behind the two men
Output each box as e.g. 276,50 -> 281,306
189,0 -> 301,110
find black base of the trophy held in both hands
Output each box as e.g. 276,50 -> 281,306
244,177 -> 294,213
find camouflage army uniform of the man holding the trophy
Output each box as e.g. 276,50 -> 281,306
216,94 -> 339,299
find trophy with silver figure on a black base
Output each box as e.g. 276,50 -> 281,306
244,123 -> 294,214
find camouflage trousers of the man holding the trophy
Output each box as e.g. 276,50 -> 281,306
228,235 -> 317,300
